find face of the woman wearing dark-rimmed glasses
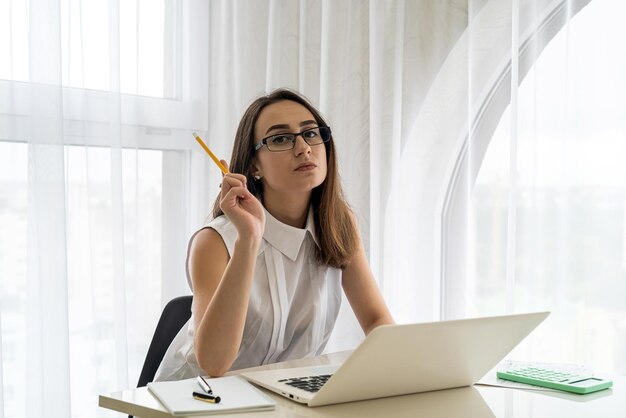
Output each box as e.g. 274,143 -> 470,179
252,100 -> 327,193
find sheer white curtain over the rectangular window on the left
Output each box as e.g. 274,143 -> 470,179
0,0 -> 208,417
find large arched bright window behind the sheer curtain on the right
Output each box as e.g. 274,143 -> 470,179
465,1 -> 626,373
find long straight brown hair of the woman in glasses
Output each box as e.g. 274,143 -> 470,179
213,89 -> 358,268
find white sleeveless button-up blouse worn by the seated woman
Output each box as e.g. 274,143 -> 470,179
155,210 -> 341,381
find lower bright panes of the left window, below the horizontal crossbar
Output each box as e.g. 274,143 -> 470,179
0,142 -> 163,416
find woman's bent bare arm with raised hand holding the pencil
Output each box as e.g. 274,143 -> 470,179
189,165 -> 265,376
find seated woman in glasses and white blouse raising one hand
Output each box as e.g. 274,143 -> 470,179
156,89 -> 393,380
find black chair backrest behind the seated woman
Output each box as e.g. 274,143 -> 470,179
137,296 -> 192,387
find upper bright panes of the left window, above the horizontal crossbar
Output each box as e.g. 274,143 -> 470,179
0,0 -> 173,97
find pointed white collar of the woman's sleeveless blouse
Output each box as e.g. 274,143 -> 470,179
263,208 -> 319,261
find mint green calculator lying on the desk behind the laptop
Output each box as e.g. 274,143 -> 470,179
496,367 -> 613,395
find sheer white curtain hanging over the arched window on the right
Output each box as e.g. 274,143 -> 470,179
424,0 -> 626,373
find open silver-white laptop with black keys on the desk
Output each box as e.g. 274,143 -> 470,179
241,312 -> 550,406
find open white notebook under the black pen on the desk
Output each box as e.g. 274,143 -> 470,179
148,376 -> 275,416
